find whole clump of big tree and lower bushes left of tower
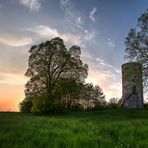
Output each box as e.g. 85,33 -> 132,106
19,37 -> 106,112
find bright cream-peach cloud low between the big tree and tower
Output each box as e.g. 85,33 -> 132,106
86,66 -> 121,101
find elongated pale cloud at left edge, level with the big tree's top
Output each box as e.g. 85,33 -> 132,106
0,35 -> 33,47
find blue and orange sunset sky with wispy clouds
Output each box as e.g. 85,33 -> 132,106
0,0 -> 148,111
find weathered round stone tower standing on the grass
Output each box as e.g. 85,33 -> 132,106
122,62 -> 143,108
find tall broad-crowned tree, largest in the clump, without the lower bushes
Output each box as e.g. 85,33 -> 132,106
20,37 -> 88,112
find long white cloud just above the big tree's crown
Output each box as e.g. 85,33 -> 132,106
25,25 -> 97,48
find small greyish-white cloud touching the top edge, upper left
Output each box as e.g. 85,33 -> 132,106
19,0 -> 42,11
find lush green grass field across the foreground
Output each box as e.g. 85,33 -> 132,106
0,110 -> 148,148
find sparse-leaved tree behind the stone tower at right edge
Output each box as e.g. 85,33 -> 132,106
125,9 -> 148,88
